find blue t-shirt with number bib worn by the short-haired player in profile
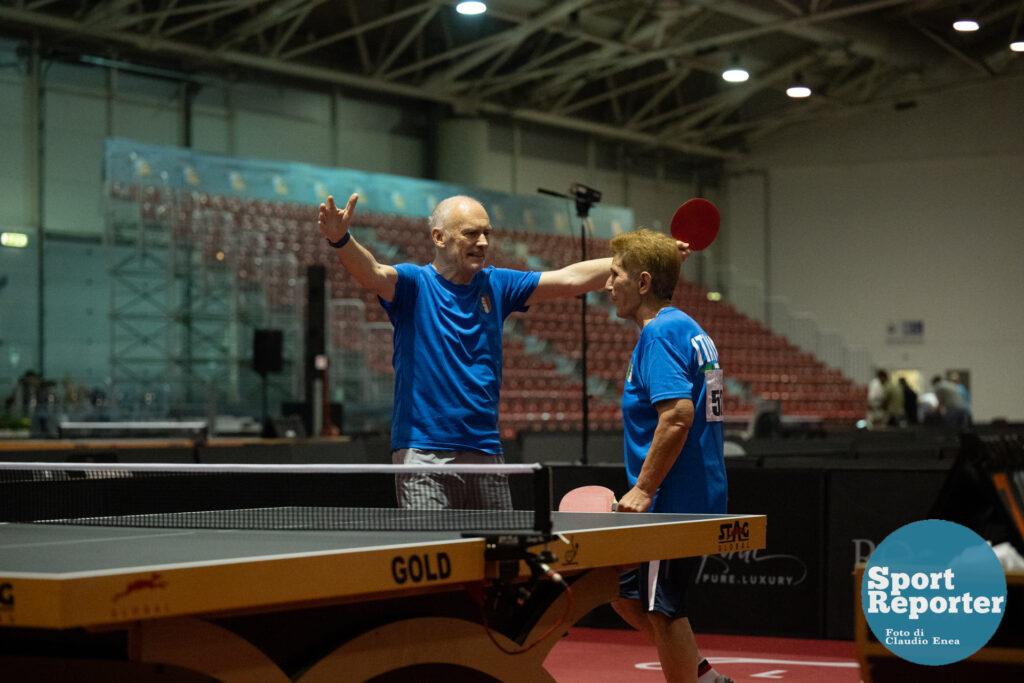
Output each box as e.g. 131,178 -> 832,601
623,307 -> 728,514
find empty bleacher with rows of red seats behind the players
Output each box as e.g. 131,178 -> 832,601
110,183 -> 866,438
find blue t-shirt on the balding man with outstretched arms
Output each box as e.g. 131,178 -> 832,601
381,263 -> 541,454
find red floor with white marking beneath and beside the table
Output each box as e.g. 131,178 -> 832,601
545,628 -> 860,683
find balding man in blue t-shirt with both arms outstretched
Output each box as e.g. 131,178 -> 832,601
318,195 -> 688,509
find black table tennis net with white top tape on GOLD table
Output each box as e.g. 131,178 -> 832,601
0,463 -> 551,531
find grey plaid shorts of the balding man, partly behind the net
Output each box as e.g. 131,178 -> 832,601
391,449 -> 512,510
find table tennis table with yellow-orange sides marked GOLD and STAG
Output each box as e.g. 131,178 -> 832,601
0,512 -> 766,683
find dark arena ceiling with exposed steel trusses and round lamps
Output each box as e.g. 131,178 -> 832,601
0,0 -> 1024,159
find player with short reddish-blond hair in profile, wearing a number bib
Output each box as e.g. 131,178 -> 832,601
605,230 -> 729,683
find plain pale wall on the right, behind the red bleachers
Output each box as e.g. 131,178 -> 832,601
728,80 -> 1024,420
